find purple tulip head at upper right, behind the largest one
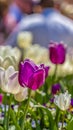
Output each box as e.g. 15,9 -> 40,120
49,42 -> 66,64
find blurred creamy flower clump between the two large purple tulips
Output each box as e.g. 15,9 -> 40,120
24,44 -> 49,64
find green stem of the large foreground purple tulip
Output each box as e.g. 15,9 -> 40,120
21,89 -> 31,130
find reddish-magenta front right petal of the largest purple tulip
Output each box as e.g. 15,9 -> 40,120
28,69 -> 45,90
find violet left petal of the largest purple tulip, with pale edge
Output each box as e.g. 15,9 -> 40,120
19,60 -> 37,87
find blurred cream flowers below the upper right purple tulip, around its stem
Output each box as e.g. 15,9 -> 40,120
49,55 -> 73,77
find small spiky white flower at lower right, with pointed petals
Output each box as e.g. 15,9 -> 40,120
54,91 -> 71,111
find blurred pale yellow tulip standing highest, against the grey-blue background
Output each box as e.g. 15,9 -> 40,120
17,31 -> 33,49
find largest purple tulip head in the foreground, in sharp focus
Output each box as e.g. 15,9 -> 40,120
19,59 -> 49,90
